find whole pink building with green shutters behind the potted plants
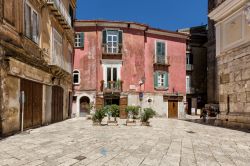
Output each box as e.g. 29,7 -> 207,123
73,20 -> 188,118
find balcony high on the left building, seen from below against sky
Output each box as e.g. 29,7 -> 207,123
47,0 -> 72,29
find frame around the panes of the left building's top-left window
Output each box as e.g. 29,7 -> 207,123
23,0 -> 40,44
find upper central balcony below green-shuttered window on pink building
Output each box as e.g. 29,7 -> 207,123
102,44 -> 122,59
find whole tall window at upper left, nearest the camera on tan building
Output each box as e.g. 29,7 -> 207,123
24,2 -> 39,43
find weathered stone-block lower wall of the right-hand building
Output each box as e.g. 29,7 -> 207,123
218,43 -> 250,123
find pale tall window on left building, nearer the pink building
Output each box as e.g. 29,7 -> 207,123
52,28 -> 64,67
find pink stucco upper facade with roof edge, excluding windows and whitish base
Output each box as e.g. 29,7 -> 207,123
74,21 -> 187,117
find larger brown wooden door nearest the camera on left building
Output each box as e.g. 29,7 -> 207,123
20,79 -> 43,129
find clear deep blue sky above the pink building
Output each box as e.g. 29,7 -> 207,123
77,0 -> 207,31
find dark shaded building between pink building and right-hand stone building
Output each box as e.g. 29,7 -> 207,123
178,25 -> 207,114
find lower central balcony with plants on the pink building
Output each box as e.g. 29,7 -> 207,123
101,80 -> 123,93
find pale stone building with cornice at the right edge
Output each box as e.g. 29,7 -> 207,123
209,0 -> 250,127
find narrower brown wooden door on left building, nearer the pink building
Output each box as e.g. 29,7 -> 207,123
51,86 -> 63,123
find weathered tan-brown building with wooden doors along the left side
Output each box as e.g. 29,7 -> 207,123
0,0 -> 76,135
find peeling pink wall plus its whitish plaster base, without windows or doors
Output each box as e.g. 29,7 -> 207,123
73,27 -> 186,117
